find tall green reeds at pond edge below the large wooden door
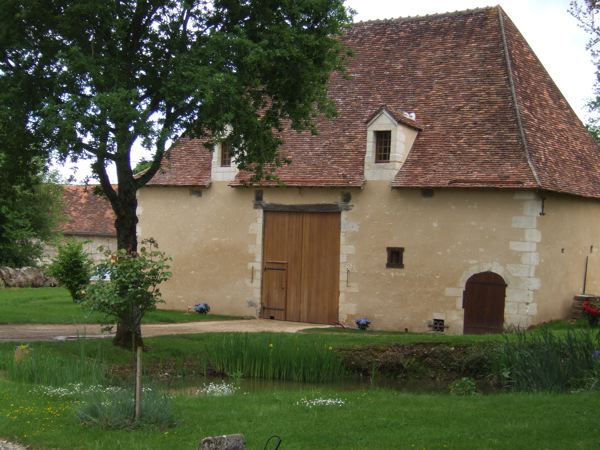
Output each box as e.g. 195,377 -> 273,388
206,333 -> 347,382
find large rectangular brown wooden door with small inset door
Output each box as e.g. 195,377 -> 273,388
261,211 -> 340,323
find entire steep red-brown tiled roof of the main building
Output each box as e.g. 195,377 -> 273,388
154,7 -> 600,197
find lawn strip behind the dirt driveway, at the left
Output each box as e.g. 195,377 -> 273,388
0,288 -> 240,324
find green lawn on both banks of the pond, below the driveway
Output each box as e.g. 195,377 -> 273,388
0,332 -> 600,450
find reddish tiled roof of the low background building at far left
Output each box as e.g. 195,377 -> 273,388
60,185 -> 117,237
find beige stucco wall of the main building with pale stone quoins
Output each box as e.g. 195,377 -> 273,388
138,181 -> 600,333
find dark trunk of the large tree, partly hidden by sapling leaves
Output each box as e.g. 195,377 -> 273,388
113,183 -> 144,351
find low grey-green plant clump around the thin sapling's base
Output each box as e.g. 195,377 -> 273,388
77,389 -> 175,429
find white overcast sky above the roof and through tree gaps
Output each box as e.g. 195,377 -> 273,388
57,0 -> 595,182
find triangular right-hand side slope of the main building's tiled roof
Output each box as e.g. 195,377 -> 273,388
500,11 -> 600,198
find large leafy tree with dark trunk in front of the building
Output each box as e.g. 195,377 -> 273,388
0,0 -> 351,346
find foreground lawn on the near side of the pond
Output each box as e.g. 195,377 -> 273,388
0,381 -> 600,450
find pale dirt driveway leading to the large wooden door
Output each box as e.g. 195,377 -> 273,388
0,319 -> 329,342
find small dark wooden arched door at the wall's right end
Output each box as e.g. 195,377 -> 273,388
463,272 -> 506,334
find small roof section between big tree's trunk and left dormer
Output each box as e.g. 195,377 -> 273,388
148,138 -> 212,187
